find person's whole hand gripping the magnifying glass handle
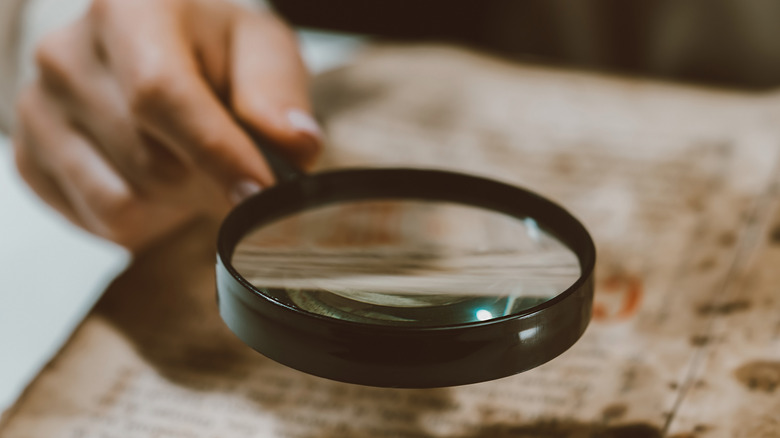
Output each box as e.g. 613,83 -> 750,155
14,0 -> 320,250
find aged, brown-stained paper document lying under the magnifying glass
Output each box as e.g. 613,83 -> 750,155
0,46 -> 780,438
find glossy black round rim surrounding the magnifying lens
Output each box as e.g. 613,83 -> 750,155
216,168 -> 596,388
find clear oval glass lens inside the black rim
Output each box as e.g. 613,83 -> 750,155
232,200 -> 581,327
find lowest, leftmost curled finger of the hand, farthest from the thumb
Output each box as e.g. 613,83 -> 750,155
17,87 -> 191,250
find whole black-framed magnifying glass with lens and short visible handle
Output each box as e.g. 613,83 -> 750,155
216,130 -> 596,388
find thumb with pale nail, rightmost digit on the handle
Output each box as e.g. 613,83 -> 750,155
231,14 -> 321,168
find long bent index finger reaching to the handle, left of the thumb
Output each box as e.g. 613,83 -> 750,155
89,1 -> 273,200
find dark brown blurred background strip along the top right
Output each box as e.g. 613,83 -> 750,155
272,0 -> 780,89
